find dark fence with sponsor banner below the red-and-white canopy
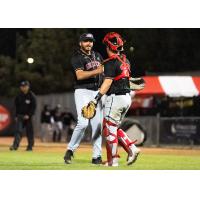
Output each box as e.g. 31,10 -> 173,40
130,114 -> 200,146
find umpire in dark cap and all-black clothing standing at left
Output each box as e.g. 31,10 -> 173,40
10,81 -> 36,151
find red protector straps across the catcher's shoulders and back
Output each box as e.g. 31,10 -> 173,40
106,54 -> 131,81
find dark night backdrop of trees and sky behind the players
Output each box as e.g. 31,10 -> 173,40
0,28 -> 200,96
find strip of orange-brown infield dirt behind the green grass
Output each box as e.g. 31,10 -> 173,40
0,137 -> 200,156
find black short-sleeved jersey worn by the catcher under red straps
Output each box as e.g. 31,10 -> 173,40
104,54 -> 130,95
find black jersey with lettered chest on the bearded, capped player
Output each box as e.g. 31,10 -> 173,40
71,50 -> 103,90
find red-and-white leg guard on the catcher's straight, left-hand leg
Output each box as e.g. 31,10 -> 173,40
103,119 -> 119,166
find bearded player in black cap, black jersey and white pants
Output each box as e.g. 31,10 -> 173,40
64,33 -> 103,164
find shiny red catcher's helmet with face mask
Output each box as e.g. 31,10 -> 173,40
103,32 -> 124,51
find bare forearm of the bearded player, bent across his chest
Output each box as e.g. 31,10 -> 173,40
76,65 -> 103,80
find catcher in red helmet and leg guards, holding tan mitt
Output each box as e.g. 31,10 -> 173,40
82,32 -> 145,166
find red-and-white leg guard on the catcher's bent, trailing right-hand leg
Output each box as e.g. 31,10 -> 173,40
117,129 -> 135,156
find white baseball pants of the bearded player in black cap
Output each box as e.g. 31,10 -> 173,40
67,89 -> 103,158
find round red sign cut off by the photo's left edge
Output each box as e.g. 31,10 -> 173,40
0,105 -> 11,131
